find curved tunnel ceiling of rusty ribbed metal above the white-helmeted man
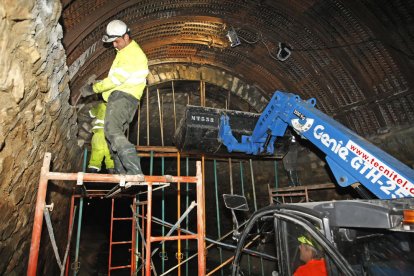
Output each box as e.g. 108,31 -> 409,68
61,0 -> 414,136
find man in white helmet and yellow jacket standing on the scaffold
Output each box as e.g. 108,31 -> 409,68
81,20 -> 149,175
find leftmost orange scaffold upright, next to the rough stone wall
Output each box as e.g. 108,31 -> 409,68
27,152 -> 51,276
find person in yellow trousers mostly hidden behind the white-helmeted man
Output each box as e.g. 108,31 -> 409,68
88,103 -> 115,174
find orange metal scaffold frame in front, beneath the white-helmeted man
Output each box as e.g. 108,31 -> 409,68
27,153 -> 206,276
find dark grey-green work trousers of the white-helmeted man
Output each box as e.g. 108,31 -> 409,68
104,90 -> 142,175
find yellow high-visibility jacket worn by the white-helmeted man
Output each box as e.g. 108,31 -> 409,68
93,40 -> 149,101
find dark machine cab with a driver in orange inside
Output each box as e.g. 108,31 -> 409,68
233,199 -> 414,276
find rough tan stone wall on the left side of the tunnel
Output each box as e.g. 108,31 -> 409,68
0,0 -> 80,275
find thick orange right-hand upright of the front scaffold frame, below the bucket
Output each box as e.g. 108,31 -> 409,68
196,161 -> 206,276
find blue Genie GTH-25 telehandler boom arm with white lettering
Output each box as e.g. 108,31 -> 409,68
219,91 -> 414,199
